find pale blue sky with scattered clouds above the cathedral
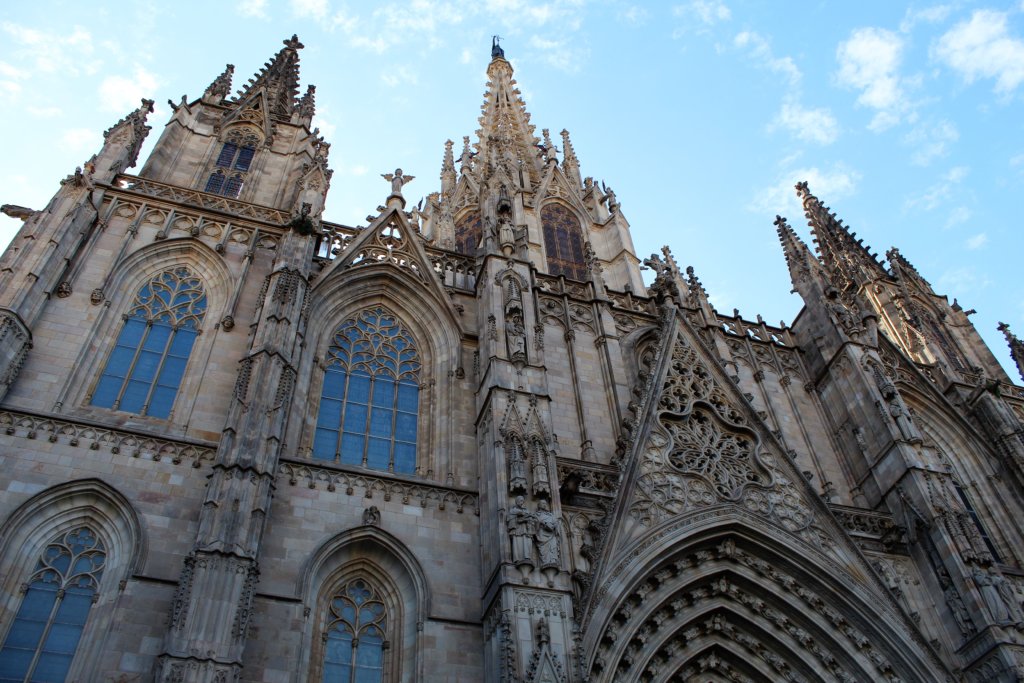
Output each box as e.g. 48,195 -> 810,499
0,0 -> 1024,380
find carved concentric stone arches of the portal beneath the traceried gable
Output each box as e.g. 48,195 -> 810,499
591,539 -> 901,683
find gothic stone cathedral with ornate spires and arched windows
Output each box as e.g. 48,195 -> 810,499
0,37 -> 1024,683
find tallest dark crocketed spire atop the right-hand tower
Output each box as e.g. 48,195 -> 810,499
797,181 -> 888,290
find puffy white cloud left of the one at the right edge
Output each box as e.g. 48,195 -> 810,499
836,28 -> 906,132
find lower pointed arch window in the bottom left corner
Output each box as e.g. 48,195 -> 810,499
0,526 -> 106,683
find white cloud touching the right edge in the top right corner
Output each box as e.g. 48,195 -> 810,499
932,9 -> 1024,94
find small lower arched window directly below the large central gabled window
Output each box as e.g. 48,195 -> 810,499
321,579 -> 388,683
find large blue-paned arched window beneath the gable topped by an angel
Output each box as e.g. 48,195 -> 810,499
312,306 -> 420,474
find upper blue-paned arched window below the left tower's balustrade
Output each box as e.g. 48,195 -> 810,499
92,266 -> 207,418
